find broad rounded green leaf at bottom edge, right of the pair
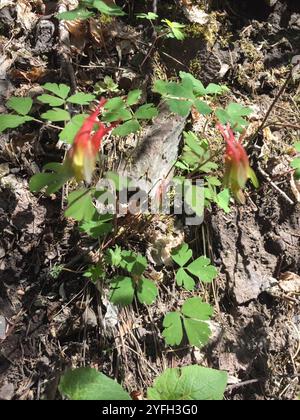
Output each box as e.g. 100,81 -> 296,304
147,365 -> 227,401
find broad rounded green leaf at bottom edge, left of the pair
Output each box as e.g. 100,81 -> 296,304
59,367 -> 131,401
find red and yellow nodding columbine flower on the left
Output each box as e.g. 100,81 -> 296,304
65,98 -> 117,183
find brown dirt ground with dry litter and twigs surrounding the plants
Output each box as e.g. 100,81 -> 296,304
0,0 -> 300,400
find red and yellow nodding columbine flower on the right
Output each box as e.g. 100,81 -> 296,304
217,124 -> 258,204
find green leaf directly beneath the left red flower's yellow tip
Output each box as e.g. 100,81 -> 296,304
65,188 -> 96,221
